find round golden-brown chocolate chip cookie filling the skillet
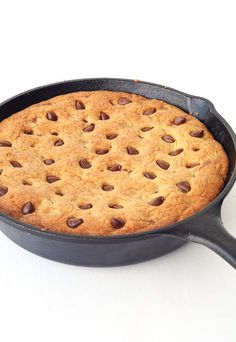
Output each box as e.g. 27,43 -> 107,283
0,91 -> 228,235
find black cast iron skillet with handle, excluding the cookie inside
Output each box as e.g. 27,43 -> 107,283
0,78 -> 236,268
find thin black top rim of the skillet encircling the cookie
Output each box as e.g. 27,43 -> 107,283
0,77 -> 236,243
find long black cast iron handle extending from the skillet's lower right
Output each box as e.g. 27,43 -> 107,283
163,205 -> 236,269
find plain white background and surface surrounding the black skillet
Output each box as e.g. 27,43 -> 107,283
0,0 -> 236,342
